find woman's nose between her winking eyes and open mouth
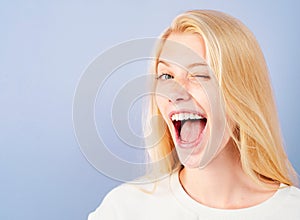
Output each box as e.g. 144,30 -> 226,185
168,82 -> 191,104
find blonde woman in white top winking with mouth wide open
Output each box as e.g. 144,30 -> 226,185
89,10 -> 300,220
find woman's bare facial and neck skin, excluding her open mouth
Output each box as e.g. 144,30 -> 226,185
156,33 -> 275,209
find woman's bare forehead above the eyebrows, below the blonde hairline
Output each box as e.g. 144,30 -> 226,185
159,33 -> 206,67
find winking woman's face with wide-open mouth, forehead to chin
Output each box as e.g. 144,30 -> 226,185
156,33 -> 229,168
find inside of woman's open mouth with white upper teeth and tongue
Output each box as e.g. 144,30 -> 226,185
171,113 -> 207,144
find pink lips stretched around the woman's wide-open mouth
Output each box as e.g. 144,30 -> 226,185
169,109 -> 208,150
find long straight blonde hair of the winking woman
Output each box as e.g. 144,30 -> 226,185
146,10 -> 296,185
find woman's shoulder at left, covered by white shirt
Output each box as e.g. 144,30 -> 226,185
89,173 -> 184,220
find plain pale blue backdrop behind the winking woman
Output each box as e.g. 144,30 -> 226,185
0,0 -> 300,220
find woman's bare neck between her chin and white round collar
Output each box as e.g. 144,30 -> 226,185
179,141 -> 274,209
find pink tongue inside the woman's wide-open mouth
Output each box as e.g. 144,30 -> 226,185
180,120 -> 205,143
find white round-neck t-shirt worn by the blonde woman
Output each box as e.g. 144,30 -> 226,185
88,172 -> 300,220
